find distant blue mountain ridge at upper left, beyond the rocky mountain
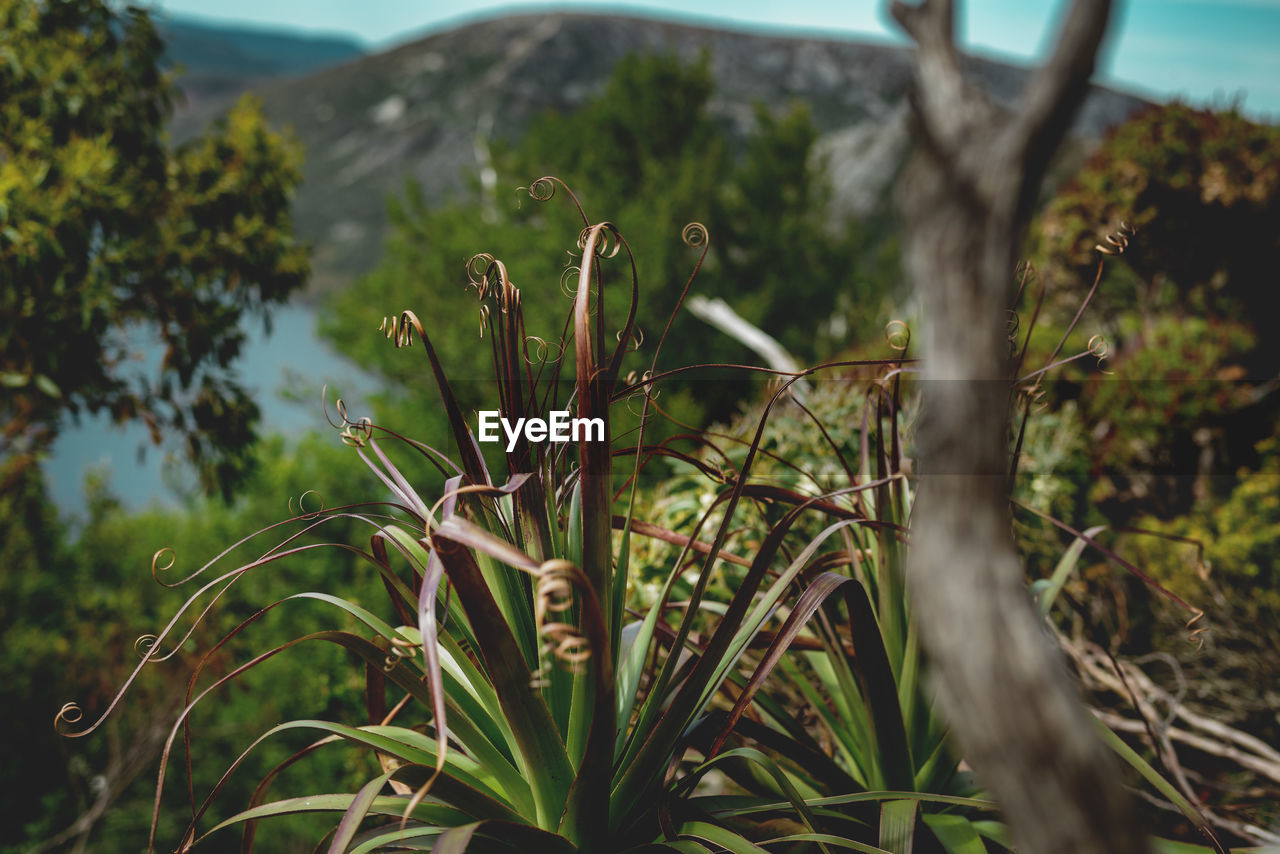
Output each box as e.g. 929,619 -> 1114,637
156,17 -> 365,108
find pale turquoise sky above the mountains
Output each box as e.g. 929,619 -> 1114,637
145,0 -> 1280,122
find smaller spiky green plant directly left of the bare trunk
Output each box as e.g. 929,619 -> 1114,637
619,350 -> 1005,851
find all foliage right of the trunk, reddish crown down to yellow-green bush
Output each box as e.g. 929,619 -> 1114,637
1019,112 -> 1280,825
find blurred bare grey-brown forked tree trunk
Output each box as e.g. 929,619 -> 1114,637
892,0 -> 1149,854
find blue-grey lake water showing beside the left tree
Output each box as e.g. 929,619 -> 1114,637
45,303 -> 376,519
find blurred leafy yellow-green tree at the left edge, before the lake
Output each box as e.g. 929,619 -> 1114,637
0,0 -> 307,493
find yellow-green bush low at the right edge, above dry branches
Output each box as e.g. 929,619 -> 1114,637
1090,435 -> 1280,827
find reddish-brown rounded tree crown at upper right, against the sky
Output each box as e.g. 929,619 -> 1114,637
1037,104 -> 1280,319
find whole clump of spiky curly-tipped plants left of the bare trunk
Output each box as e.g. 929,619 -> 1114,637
60,179 -> 1244,854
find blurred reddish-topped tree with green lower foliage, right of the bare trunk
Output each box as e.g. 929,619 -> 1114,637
1033,104 -> 1280,521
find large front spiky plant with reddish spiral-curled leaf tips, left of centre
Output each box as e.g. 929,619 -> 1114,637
57,179 -> 921,851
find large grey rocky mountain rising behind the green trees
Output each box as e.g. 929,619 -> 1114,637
162,14 -> 1143,291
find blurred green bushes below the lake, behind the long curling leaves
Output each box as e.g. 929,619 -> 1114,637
0,437 -> 379,853
